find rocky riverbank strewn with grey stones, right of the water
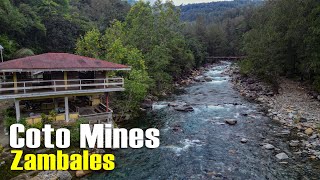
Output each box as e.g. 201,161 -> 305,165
229,65 -> 320,160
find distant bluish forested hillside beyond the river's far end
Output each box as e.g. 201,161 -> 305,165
180,0 -> 263,56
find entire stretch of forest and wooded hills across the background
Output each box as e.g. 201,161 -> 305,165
0,0 -> 320,117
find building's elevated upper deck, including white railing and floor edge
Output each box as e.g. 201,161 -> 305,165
0,78 -> 124,100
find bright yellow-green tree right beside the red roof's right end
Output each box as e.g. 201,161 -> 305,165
77,27 -> 150,118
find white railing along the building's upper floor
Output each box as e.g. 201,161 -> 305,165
0,78 -> 124,94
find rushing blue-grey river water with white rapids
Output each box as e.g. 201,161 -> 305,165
89,62 -> 320,180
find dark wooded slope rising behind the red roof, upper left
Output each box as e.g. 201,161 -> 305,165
0,0 -> 130,57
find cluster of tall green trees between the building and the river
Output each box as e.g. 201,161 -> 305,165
76,1 -> 206,116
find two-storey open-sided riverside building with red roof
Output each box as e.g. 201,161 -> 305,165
0,53 -> 131,124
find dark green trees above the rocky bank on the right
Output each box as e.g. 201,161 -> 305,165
241,0 -> 320,92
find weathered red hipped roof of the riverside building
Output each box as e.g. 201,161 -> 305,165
0,53 -> 130,72
